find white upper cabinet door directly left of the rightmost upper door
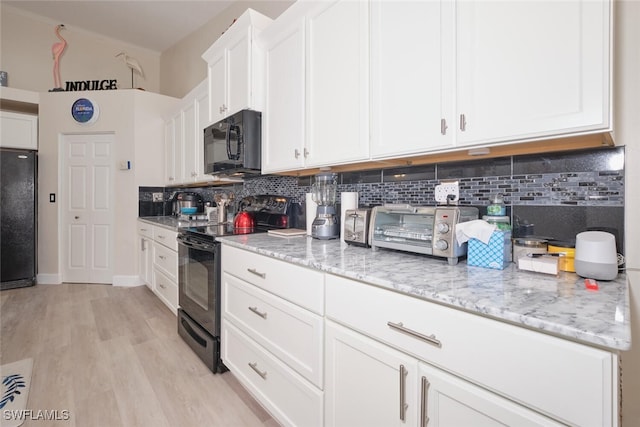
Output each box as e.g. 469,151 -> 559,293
371,0 -> 455,158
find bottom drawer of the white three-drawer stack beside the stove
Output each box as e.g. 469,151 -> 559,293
221,319 -> 323,426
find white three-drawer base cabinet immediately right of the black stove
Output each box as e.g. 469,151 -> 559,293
221,245 -> 324,426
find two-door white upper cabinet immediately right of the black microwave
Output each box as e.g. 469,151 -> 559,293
259,1 -> 369,173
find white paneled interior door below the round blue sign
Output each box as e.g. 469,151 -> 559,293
60,134 -> 115,283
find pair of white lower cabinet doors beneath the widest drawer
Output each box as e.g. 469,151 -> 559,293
325,320 -> 561,427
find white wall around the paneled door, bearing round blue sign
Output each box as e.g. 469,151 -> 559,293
38,90 -> 179,285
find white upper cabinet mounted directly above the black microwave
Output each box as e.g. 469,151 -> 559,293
202,9 -> 272,122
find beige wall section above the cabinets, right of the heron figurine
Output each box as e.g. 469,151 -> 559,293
160,0 -> 293,98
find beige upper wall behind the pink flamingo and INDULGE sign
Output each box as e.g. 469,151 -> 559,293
0,2 -> 160,93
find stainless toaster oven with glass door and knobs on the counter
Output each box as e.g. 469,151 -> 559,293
369,204 -> 479,265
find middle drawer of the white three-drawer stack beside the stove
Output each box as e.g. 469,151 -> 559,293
222,273 -> 323,388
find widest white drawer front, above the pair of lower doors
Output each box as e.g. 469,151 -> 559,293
326,275 -> 617,426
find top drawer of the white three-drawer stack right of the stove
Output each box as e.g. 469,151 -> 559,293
222,245 -> 324,315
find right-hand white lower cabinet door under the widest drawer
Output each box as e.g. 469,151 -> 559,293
419,363 -> 562,427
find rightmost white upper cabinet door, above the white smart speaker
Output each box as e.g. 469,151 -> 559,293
451,0 -> 610,145
